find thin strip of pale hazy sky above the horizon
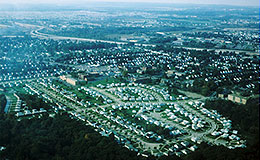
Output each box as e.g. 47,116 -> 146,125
0,0 -> 259,7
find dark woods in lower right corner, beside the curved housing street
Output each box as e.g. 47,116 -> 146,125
185,99 -> 259,160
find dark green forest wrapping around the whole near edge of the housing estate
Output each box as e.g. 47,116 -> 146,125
0,97 -> 259,160
